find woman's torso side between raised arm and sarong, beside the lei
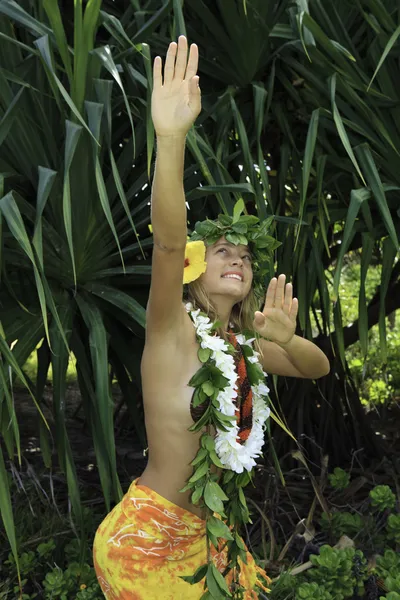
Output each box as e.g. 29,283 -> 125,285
140,314 -> 208,517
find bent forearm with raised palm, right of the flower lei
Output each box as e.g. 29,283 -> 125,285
253,275 -> 330,379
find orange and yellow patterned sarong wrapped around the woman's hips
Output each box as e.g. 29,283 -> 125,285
93,479 -> 268,600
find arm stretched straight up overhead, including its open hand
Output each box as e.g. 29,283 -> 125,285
146,36 -> 201,337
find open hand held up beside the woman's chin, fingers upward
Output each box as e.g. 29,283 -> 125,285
253,275 -> 299,345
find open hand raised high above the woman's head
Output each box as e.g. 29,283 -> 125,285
151,35 -> 201,137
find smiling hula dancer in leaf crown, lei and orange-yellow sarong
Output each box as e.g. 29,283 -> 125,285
94,36 -> 329,600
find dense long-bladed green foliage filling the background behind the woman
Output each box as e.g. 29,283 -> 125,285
0,0 -> 400,596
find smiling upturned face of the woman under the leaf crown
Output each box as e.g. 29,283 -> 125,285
199,237 -> 253,303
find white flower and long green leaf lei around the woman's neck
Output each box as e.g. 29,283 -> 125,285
181,303 -> 270,600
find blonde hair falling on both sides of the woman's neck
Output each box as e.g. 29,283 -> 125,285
186,279 -> 259,339
